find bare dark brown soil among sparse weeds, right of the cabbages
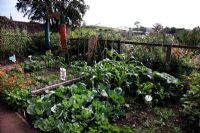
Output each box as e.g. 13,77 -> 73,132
116,105 -> 191,133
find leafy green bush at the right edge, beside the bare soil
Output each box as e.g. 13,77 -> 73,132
181,73 -> 200,130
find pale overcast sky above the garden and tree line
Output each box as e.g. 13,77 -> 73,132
0,0 -> 200,28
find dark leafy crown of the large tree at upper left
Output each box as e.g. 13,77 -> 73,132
16,0 -> 88,27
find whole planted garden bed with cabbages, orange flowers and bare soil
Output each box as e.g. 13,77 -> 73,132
0,52 -> 200,133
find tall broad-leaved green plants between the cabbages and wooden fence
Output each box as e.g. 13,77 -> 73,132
72,53 -> 182,104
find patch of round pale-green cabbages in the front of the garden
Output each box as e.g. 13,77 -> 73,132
27,83 -> 126,133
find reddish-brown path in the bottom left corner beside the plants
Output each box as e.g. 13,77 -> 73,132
0,103 -> 37,133
